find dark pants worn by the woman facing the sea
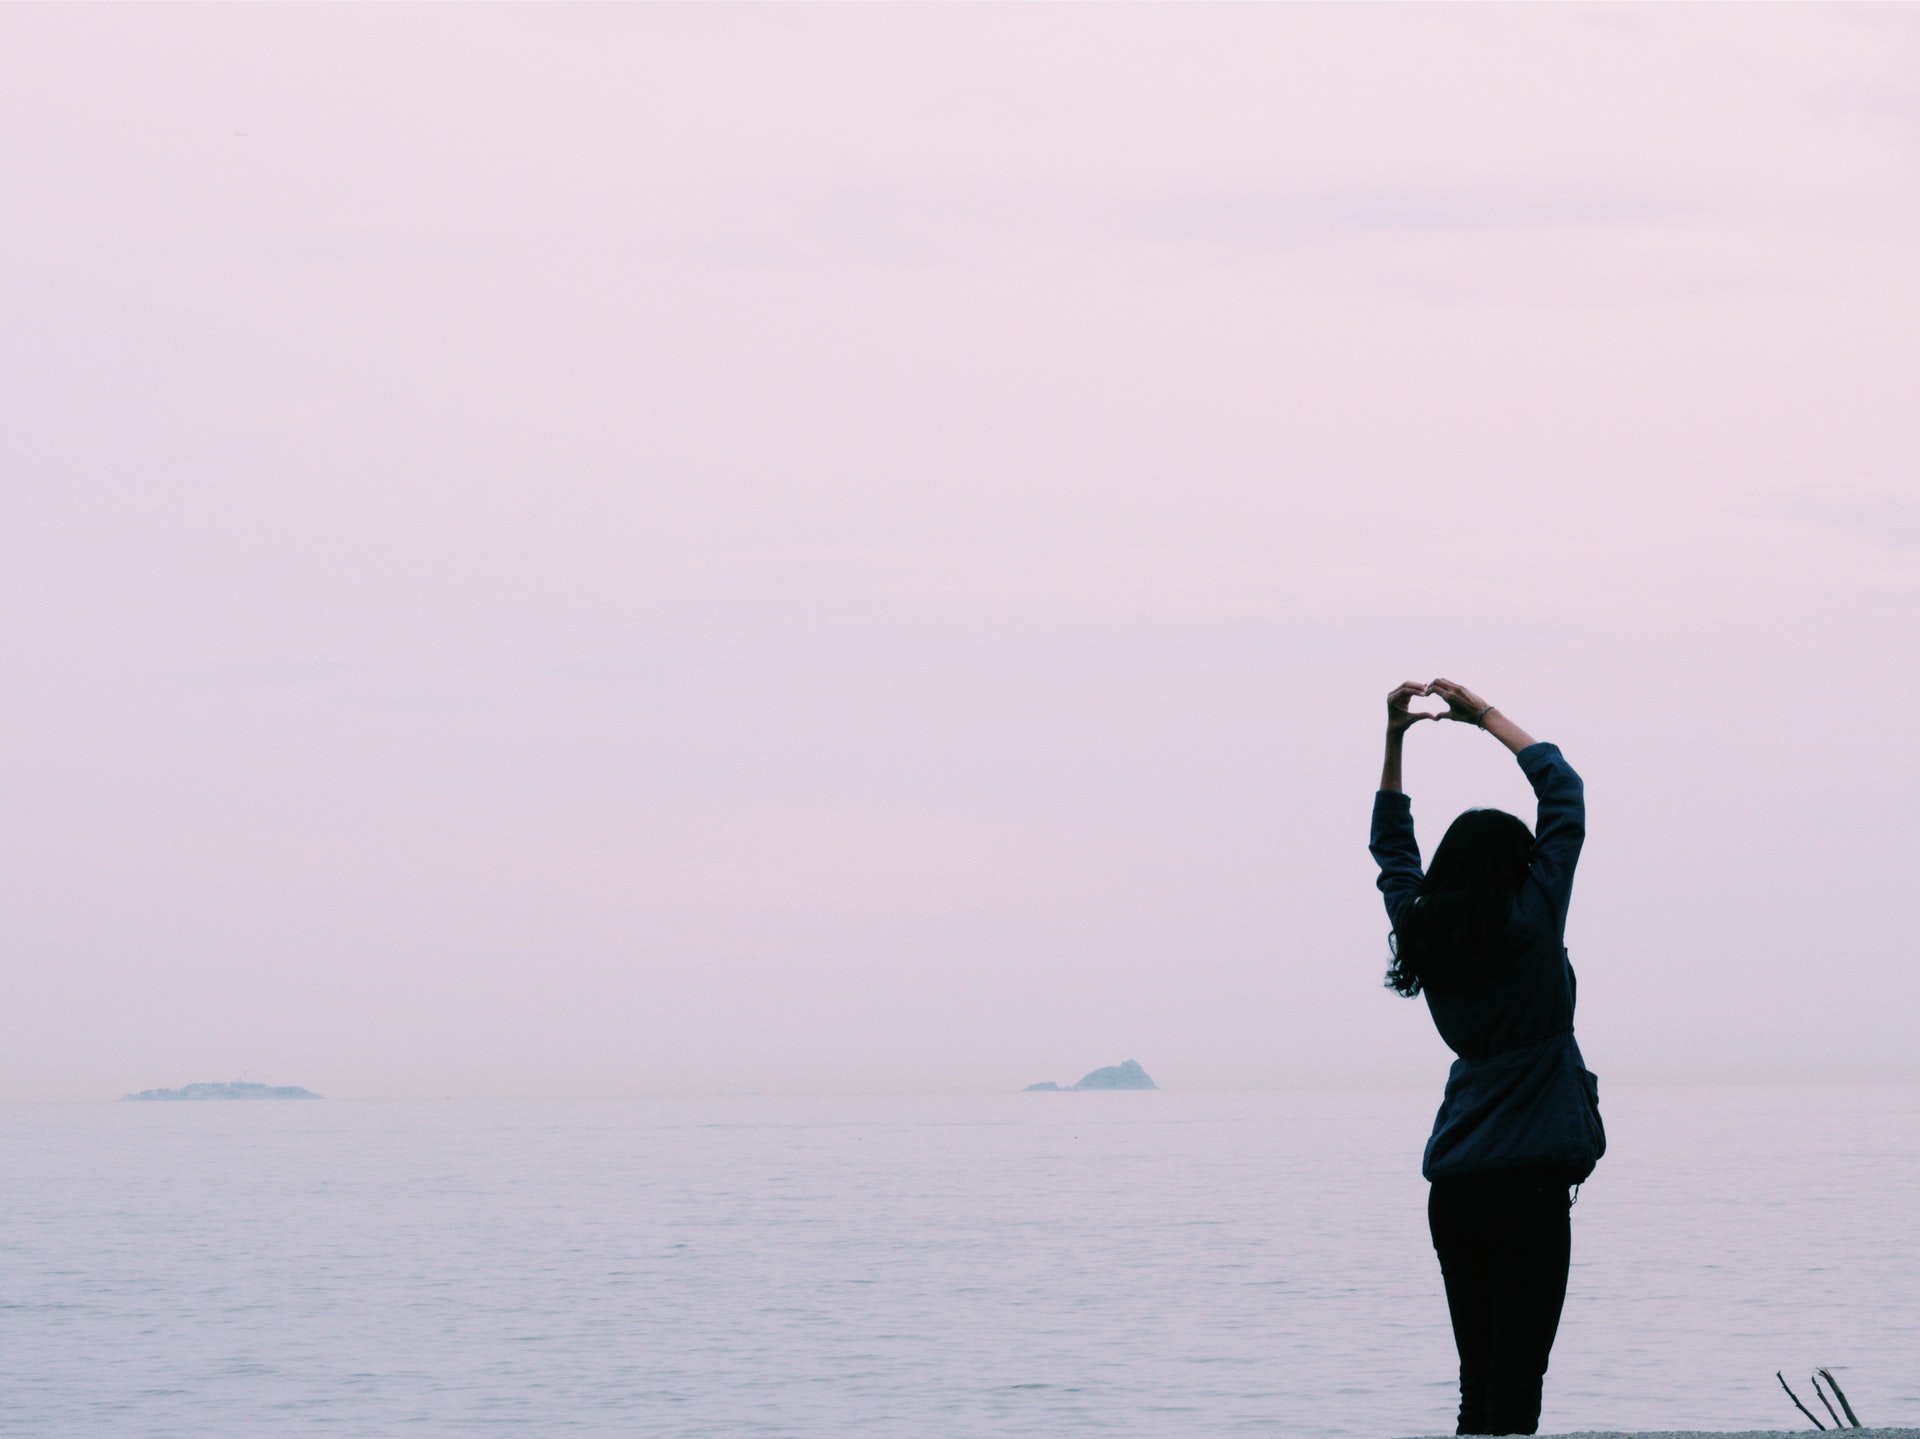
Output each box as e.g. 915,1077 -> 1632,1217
1427,1170 -> 1572,1433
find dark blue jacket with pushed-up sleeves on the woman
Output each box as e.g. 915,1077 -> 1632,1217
1369,744 -> 1607,1180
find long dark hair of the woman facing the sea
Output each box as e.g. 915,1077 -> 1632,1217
1386,809 -> 1534,999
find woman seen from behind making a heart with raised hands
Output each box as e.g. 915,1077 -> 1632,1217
1371,680 -> 1607,1433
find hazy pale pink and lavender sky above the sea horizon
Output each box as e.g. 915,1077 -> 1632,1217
0,6 -> 1920,1097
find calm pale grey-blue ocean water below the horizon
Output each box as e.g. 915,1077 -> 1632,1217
0,1085 -> 1920,1439
